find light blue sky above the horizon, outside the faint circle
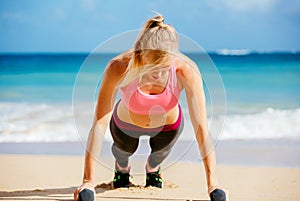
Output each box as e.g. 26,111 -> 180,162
0,0 -> 300,53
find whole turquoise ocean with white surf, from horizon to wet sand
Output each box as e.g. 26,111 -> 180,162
0,51 -> 300,146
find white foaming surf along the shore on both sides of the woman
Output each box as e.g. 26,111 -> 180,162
0,102 -> 300,142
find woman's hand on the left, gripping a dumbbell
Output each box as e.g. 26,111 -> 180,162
74,182 -> 95,201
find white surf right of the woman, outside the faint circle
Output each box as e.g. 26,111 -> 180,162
220,108 -> 300,140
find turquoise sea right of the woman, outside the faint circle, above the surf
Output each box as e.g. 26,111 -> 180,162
215,54 -> 300,109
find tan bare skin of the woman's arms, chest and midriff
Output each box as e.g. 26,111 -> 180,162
74,51 -> 218,200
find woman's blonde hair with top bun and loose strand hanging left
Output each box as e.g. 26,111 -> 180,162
120,15 -> 178,87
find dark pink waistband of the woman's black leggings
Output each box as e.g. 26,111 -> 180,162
112,102 -> 182,133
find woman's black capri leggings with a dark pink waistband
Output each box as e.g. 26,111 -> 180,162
110,105 -> 184,167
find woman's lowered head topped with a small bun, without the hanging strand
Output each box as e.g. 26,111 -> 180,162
133,15 -> 178,67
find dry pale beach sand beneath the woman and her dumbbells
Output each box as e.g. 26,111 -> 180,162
0,154 -> 300,201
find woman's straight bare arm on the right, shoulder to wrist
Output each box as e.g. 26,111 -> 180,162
177,61 -> 218,194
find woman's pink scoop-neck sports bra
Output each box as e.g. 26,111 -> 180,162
120,65 -> 181,115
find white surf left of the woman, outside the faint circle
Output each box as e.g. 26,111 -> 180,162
0,103 -> 77,142
